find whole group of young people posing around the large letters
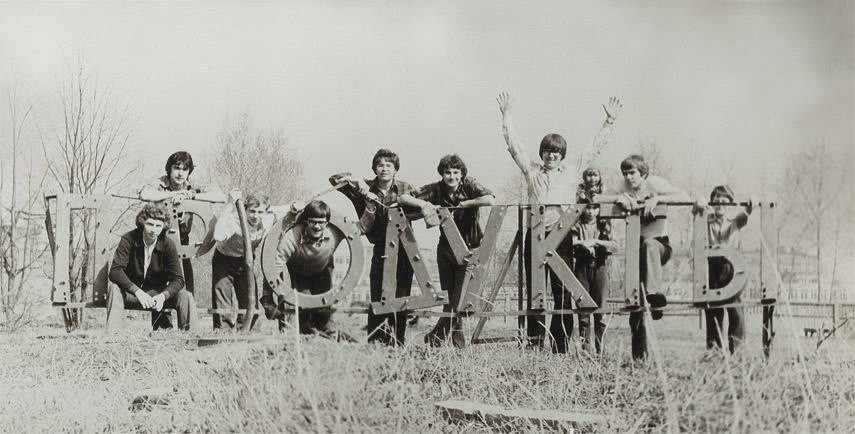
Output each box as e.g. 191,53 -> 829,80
103,93 -> 751,358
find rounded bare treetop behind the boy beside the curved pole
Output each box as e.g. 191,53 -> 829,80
213,112 -> 307,203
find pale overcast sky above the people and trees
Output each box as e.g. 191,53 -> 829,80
0,0 -> 855,209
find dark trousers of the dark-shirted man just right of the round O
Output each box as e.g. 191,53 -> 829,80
368,244 -> 413,345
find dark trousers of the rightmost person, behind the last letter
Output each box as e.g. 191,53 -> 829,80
704,257 -> 745,353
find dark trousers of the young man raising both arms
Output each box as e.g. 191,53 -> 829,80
523,230 -> 573,353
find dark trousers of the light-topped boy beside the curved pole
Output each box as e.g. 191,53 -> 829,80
211,249 -> 259,329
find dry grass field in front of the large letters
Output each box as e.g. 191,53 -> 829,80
0,310 -> 855,432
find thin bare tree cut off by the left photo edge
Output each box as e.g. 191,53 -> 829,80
0,82 -> 47,329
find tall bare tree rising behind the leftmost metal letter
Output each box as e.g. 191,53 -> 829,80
42,59 -> 136,328
